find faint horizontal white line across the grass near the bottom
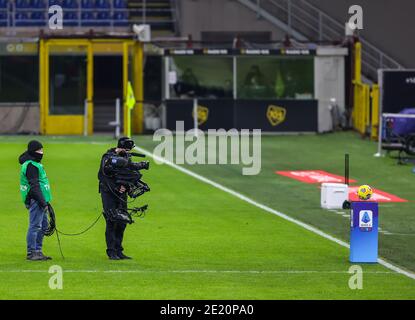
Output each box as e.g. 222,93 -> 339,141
0,269 -> 398,275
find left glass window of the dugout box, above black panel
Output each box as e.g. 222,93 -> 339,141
168,56 -> 233,99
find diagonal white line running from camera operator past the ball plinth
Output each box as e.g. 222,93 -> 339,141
135,147 -> 415,280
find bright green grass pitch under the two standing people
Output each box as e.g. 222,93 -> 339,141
0,133 -> 415,299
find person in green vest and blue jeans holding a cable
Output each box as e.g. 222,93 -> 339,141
19,140 -> 52,261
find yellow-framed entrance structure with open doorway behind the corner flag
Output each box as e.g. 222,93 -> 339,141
39,38 -> 143,135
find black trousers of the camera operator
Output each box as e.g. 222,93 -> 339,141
101,190 -> 127,256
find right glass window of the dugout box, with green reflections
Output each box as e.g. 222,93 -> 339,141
237,57 -> 314,99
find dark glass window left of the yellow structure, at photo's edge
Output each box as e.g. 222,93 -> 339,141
0,55 -> 39,103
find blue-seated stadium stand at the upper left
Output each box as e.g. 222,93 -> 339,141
0,0 -> 176,35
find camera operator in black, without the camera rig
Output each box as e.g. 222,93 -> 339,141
98,137 -> 135,260
